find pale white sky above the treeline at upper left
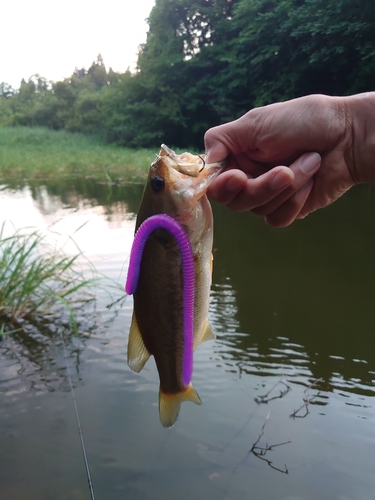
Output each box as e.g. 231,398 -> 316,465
0,0 -> 155,89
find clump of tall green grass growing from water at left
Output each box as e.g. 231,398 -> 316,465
0,224 -> 121,333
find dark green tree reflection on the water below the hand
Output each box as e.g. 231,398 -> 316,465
212,191 -> 375,395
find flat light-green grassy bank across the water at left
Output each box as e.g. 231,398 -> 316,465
0,127 -> 157,182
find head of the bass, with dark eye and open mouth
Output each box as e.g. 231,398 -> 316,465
137,144 -> 224,240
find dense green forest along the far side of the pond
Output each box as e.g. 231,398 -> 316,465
0,0 -> 375,148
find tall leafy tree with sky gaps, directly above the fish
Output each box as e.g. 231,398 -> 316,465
106,0 -> 238,147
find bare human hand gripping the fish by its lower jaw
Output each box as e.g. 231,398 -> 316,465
205,95 -> 361,227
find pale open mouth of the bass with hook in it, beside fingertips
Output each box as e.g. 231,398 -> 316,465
159,144 -> 226,199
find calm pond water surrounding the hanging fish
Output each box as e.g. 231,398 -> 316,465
0,179 -> 375,500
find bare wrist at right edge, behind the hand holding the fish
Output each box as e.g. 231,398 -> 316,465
342,92 -> 375,184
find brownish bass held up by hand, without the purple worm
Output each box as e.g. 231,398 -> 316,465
127,144 -> 224,427
